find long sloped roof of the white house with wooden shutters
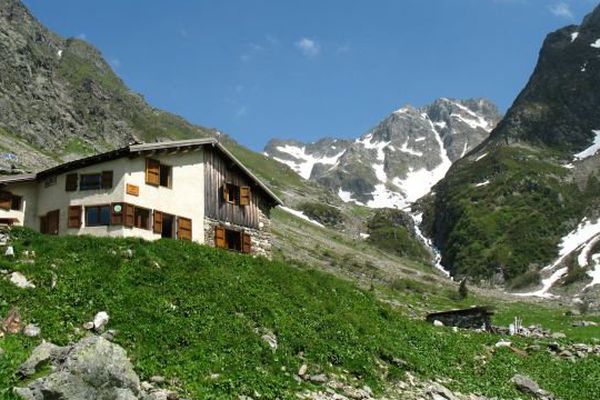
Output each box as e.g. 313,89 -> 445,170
6,138 -> 283,205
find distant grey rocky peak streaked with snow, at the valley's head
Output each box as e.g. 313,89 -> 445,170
265,98 -> 500,208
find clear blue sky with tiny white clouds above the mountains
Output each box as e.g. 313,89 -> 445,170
25,0 -> 597,150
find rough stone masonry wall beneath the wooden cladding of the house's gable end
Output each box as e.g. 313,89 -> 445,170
204,210 -> 273,259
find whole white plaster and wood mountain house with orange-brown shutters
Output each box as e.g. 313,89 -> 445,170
0,139 -> 282,257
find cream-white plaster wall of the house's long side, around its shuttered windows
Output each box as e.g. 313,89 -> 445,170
32,149 -> 204,243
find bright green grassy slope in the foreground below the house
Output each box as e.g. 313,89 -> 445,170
0,231 -> 600,399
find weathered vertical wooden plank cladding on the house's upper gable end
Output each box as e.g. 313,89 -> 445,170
204,146 -> 273,229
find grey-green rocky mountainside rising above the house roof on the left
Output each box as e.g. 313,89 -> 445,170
0,0 -> 216,170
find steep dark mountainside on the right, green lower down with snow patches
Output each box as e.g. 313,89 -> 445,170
424,2 -> 600,296
